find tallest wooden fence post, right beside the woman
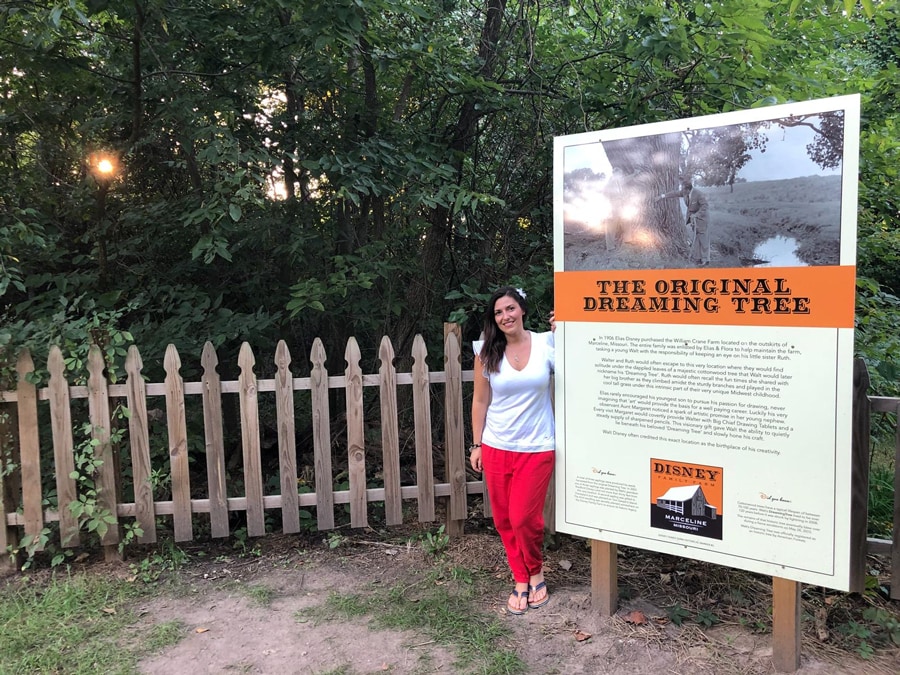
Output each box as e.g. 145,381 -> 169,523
444,323 -> 468,537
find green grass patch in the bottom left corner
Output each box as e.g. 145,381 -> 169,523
0,574 -> 163,675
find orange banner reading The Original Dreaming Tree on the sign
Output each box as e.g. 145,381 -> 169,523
555,265 -> 856,328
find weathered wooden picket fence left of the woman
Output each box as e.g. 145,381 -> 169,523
0,324 -> 489,557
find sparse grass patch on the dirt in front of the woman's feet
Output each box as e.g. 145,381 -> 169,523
296,568 -> 526,675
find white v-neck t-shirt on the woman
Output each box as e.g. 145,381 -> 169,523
472,333 -> 556,452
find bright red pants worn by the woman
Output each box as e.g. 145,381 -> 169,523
481,445 -> 555,583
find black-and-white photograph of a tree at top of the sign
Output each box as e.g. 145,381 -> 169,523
563,110 -> 844,271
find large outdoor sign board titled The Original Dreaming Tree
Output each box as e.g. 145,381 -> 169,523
554,96 -> 859,590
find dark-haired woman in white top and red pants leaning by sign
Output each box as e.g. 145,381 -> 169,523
469,286 -> 556,614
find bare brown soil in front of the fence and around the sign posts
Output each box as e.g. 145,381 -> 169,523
128,530 -> 900,675
